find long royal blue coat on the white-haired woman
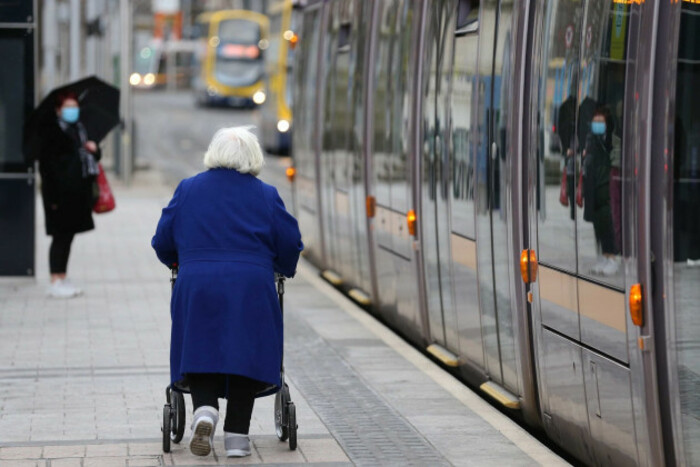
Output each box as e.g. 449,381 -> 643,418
151,168 -> 303,397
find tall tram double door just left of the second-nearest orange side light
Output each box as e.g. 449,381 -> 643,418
473,1 -> 520,394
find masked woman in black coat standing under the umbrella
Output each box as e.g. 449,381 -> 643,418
34,93 -> 101,298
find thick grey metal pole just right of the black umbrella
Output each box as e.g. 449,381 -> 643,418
119,0 -> 133,185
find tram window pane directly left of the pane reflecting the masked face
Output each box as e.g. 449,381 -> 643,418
533,2 -> 583,272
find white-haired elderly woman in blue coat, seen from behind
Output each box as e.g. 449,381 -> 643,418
151,127 -> 303,457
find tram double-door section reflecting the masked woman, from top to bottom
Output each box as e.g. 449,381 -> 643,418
527,0 -> 648,465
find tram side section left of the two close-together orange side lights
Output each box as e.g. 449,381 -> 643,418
320,0 -> 371,291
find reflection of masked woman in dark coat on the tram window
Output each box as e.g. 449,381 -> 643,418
582,106 -> 619,276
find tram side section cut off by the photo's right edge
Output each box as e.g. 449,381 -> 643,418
673,3 -> 700,465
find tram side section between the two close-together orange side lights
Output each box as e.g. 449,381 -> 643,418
366,0 -> 432,344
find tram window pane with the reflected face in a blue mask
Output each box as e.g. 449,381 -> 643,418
575,0 -> 630,287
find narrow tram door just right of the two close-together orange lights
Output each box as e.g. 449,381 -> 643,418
419,1 -> 459,353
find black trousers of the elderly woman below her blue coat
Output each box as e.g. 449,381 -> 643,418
187,373 -> 262,435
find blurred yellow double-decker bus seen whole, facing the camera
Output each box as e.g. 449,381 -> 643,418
193,10 -> 270,107
